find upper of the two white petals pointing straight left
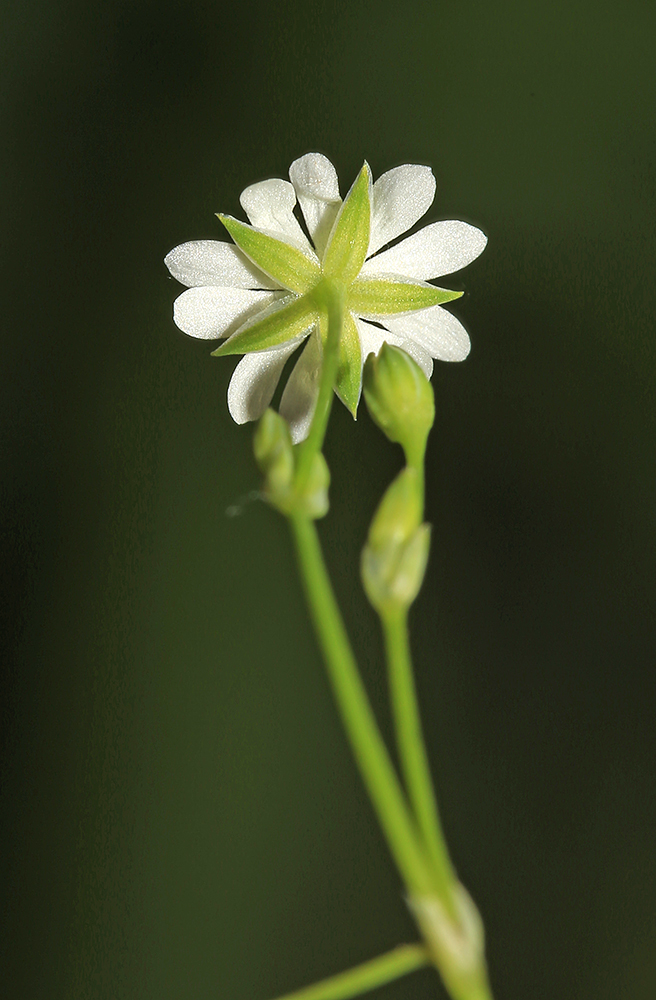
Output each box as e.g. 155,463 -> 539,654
164,240 -> 280,288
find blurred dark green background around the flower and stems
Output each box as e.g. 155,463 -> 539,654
0,0 -> 656,1000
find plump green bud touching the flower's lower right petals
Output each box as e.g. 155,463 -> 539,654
363,344 -> 435,465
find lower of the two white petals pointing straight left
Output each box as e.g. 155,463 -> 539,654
173,287 -> 279,340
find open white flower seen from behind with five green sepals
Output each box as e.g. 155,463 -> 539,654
165,153 -> 487,442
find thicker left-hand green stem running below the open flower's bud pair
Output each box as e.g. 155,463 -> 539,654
290,515 -> 433,892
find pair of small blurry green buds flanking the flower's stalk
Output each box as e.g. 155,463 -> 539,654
253,409 -> 330,519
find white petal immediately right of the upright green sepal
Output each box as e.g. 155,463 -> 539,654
369,163 -> 436,254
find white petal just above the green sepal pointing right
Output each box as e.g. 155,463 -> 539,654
361,219 -> 487,280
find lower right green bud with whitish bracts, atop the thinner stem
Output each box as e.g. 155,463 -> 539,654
360,468 -> 430,614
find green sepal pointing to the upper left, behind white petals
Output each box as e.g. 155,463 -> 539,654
219,214 -> 320,294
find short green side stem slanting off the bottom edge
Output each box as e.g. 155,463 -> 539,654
270,944 -> 430,1000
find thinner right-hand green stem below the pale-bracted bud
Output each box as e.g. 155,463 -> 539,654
381,608 -> 457,919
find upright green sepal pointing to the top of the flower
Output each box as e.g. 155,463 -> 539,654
323,163 -> 371,284
